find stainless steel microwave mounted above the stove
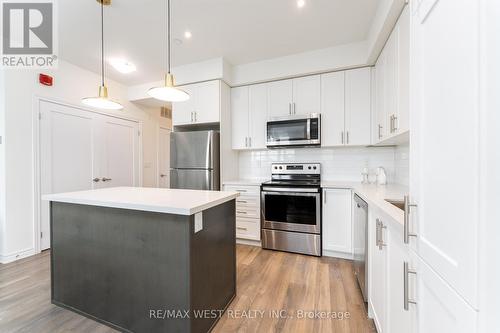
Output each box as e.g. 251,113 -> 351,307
266,113 -> 321,148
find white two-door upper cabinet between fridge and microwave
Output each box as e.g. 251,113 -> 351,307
231,84 -> 268,150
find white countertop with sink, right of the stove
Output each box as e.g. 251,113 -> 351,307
321,181 -> 409,225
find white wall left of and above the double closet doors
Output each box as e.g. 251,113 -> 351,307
0,61 -> 162,262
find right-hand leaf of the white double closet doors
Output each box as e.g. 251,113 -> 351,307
98,115 -> 140,187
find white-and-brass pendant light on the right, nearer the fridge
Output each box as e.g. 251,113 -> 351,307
148,0 -> 189,102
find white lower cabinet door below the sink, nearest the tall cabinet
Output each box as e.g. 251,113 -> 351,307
387,222 -> 411,333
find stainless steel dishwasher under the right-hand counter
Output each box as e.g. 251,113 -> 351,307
353,194 -> 368,302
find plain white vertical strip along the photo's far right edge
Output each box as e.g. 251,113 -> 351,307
478,0 -> 500,332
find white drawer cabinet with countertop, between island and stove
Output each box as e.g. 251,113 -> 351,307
224,185 -> 260,241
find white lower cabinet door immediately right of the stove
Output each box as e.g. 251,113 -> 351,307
323,189 -> 352,254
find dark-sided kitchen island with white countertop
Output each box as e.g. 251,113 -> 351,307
44,187 -> 238,332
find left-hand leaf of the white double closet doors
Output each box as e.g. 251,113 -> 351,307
40,102 -> 97,250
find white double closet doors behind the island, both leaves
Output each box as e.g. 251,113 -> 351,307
39,101 -> 141,250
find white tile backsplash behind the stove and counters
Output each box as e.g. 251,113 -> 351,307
239,147 -> 408,184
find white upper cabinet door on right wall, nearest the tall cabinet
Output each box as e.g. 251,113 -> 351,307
394,6 -> 410,133
